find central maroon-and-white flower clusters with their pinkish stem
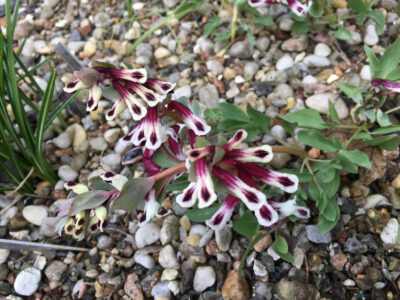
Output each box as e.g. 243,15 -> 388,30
65,64 -> 309,239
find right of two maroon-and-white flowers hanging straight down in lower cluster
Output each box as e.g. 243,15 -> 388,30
195,158 -> 217,208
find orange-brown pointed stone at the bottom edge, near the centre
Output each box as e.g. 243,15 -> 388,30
222,270 -> 250,300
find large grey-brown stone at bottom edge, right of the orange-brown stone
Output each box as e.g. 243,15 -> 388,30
275,277 -> 315,300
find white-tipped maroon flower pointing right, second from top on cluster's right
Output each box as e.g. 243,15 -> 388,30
238,163 -> 299,193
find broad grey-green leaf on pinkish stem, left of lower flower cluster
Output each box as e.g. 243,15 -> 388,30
114,177 -> 155,212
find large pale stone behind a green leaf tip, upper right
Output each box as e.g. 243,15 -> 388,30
306,93 -> 349,119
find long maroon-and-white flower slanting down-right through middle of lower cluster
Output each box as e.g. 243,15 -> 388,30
212,166 -> 266,211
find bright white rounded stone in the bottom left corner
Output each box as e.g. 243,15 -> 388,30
14,267 -> 42,296
